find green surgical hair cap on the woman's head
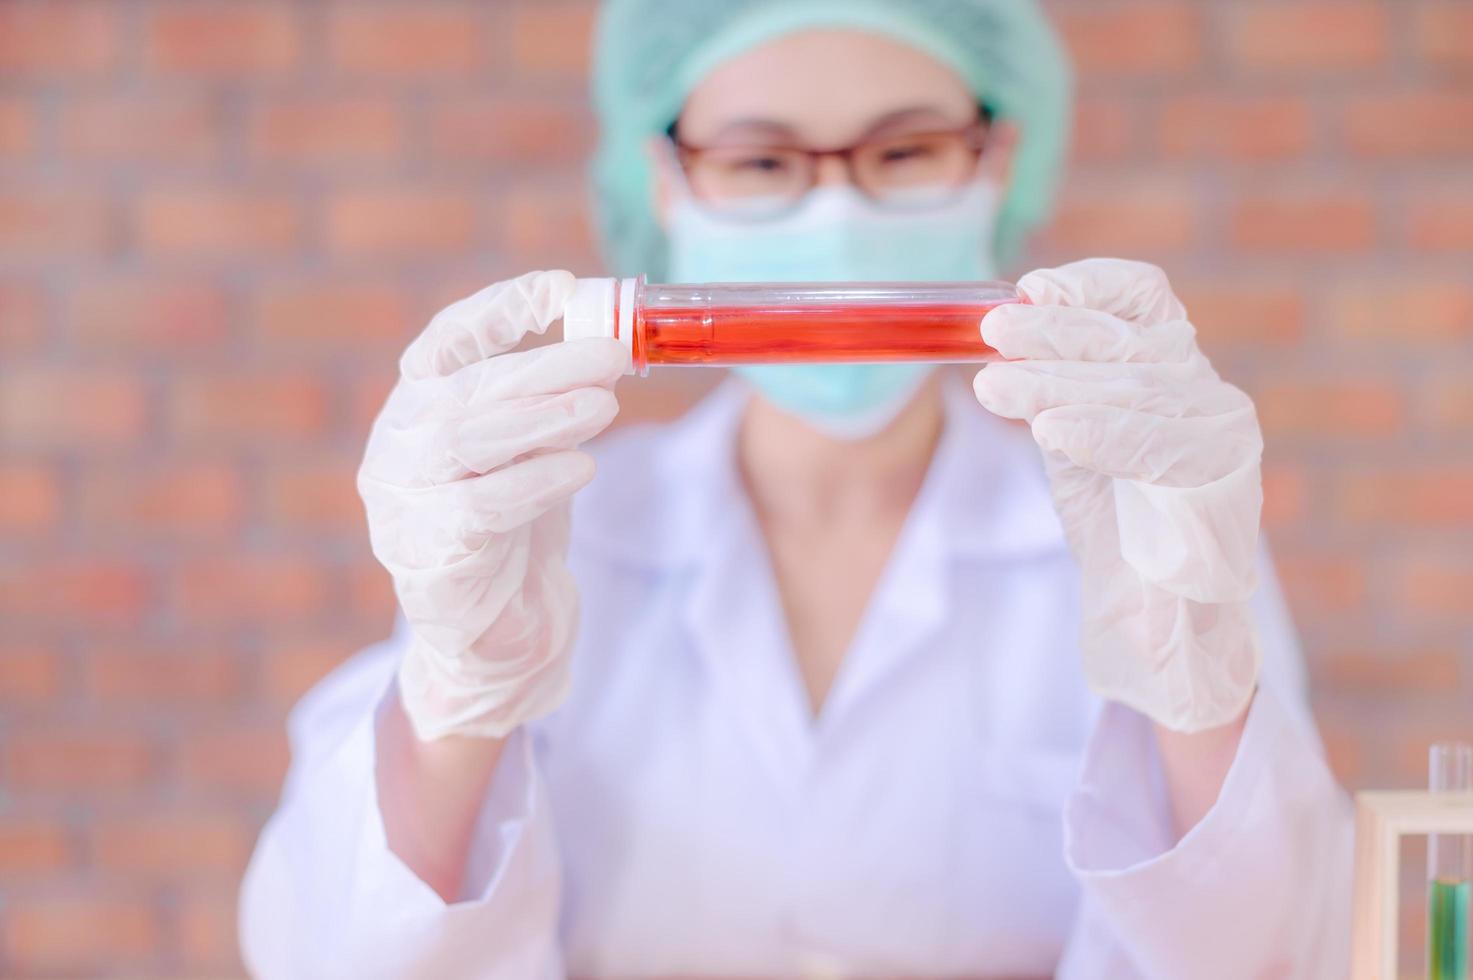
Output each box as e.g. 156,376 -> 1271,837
592,0 -> 1069,279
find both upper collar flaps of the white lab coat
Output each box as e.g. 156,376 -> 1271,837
574,373 -> 1066,570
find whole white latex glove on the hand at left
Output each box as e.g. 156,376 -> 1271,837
358,273 -> 629,738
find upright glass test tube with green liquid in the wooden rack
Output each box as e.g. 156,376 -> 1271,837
1427,743 -> 1473,980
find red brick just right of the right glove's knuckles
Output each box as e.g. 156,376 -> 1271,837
1254,379 -> 1407,439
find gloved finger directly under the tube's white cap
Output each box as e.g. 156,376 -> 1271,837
447,337 -> 629,413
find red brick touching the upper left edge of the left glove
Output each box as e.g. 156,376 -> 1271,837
255,277 -> 420,352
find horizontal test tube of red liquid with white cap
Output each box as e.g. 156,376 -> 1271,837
563,276 -> 1022,374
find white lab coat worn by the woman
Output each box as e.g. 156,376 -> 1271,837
242,385 -> 1351,980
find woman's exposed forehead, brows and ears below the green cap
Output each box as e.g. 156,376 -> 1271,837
651,29 -> 1012,221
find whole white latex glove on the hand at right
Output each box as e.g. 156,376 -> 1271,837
974,259 -> 1262,731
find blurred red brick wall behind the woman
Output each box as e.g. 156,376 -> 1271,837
0,0 -> 1473,976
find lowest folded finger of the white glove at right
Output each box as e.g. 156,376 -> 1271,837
1033,402 -> 1264,488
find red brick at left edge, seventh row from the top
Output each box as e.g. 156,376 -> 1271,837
0,557 -> 153,626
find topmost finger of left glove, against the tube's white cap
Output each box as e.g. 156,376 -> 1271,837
399,270 -> 576,380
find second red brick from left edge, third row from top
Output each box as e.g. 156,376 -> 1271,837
137,189 -> 302,256
